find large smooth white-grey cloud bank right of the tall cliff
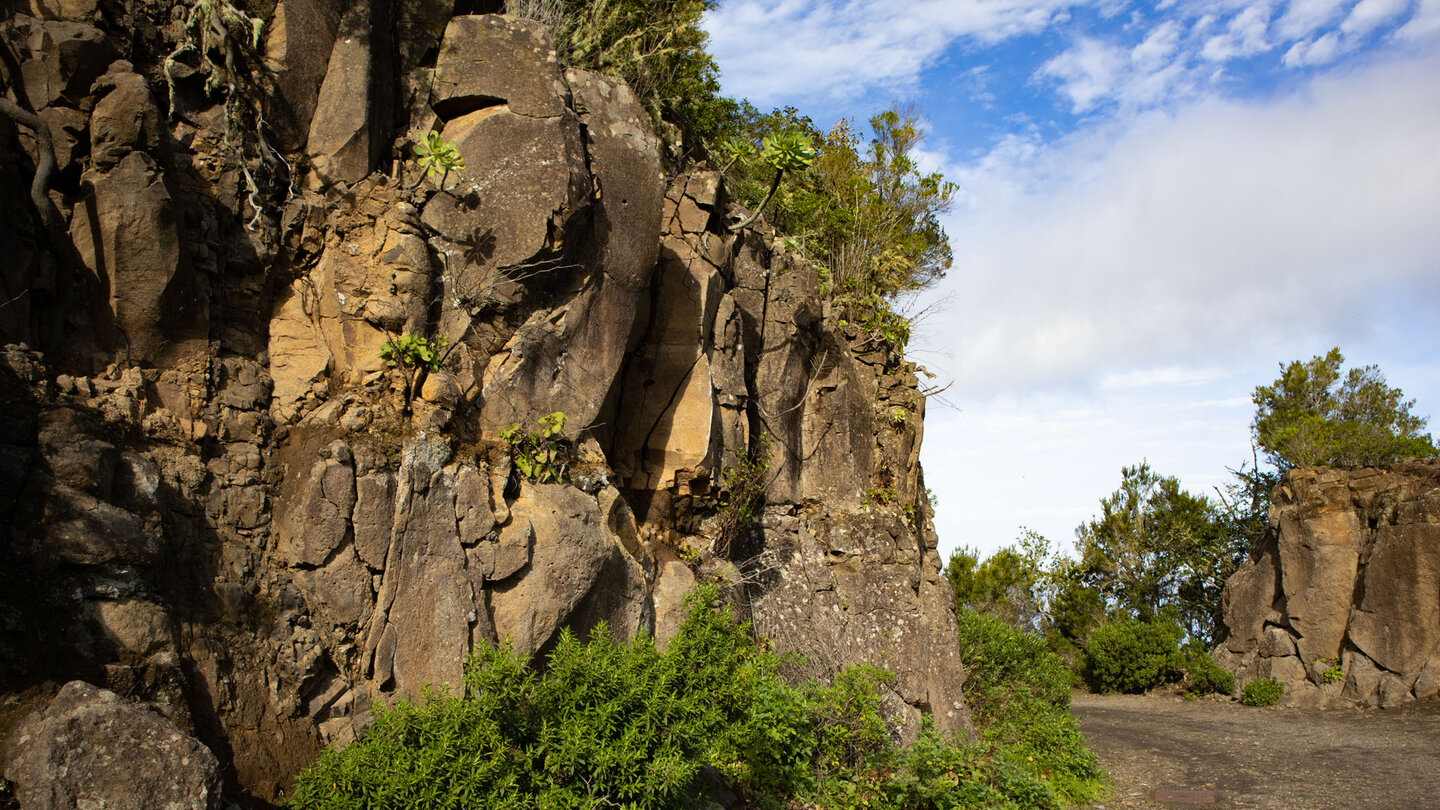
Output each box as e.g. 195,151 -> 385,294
927,51 -> 1440,391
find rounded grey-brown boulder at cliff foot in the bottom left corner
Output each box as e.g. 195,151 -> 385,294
6,680 -> 223,810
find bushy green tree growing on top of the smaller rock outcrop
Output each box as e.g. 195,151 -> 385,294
1251,349 -> 1436,473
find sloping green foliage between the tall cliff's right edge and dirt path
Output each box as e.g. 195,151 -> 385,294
952,611 -> 1103,804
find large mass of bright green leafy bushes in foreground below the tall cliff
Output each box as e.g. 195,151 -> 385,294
288,588 -> 1093,810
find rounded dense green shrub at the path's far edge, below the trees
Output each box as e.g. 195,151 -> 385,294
1083,620 -> 1182,693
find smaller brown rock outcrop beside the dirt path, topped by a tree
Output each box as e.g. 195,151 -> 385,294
1214,461 -> 1440,706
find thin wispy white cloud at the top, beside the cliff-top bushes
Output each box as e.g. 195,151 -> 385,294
704,0 -> 1083,105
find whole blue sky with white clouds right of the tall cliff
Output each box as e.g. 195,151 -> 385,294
706,0 -> 1440,553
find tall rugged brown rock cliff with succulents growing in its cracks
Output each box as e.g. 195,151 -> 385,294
0,0 -> 969,806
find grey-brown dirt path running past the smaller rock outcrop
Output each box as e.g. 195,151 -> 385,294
1073,693 -> 1440,810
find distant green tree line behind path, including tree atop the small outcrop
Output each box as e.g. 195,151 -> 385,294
946,343 -> 1437,691
